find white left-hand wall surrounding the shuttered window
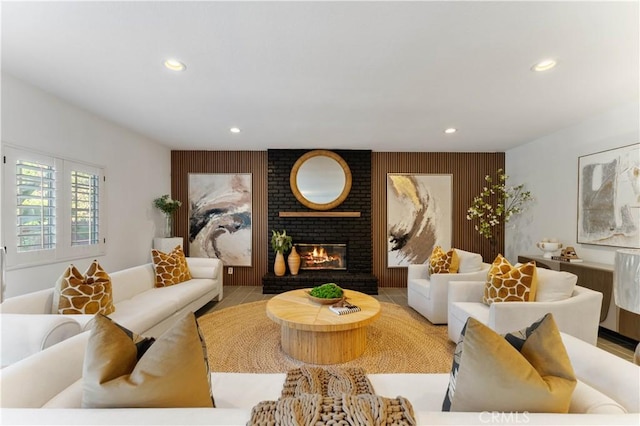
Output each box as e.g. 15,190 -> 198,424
2,73 -> 171,297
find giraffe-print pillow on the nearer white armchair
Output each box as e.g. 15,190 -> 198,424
482,255 -> 538,305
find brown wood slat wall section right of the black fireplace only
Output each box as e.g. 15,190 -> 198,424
371,152 -> 504,287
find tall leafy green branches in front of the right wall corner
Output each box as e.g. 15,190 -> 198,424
467,169 -> 533,256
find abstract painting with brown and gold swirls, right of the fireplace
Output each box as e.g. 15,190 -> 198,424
387,173 -> 453,268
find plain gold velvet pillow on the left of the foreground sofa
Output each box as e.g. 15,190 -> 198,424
82,313 -> 214,408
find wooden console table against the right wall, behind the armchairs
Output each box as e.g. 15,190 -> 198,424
518,254 -> 640,341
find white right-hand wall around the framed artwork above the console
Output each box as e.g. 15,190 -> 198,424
505,101 -> 640,265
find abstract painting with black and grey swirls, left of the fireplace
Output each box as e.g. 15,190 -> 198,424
188,173 -> 252,266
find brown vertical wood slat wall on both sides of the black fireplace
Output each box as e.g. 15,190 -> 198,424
171,151 -> 504,287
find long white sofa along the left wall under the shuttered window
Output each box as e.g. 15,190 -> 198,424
0,257 -> 223,367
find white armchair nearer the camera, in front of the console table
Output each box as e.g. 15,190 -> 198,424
448,268 -> 602,345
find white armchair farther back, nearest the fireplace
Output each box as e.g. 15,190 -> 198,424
407,249 -> 490,324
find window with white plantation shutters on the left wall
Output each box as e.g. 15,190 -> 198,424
2,147 -> 106,267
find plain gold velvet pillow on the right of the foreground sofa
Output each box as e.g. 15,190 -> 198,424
442,314 -> 577,413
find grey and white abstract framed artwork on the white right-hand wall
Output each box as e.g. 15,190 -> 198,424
577,144 -> 640,248
